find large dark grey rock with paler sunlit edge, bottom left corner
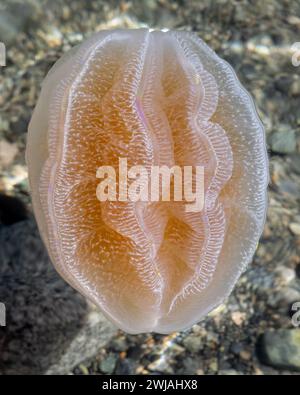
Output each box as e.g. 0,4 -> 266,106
0,220 -> 116,375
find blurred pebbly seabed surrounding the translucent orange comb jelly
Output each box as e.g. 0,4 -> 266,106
0,0 -> 300,375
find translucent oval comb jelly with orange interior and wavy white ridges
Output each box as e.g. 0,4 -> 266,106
26,29 -> 268,333
